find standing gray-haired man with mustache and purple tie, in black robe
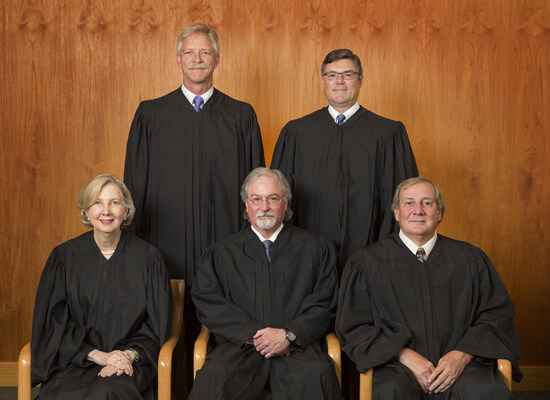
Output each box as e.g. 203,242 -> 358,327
124,24 -> 264,396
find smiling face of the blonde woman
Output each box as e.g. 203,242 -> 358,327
86,183 -> 128,234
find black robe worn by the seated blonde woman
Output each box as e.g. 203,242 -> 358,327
31,231 -> 171,400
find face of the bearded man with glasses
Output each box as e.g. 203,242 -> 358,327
246,175 -> 287,238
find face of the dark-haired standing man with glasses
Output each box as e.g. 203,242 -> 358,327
322,60 -> 362,112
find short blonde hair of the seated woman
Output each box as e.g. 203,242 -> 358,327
78,174 -> 136,226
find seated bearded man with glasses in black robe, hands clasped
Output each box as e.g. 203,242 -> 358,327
190,168 -> 341,400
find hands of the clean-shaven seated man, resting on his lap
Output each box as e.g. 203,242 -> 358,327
399,348 -> 473,393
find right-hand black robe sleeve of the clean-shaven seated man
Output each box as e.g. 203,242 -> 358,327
456,249 -> 521,381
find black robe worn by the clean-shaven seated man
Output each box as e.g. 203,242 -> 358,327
336,234 -> 521,396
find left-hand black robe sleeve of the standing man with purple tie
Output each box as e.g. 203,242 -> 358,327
124,103 -> 150,237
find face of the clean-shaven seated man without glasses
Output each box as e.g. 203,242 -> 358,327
393,182 -> 441,245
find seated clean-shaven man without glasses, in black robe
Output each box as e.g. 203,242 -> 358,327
336,178 -> 521,400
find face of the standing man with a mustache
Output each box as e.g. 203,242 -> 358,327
176,33 -> 218,88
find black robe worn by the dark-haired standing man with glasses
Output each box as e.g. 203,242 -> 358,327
271,107 -> 418,268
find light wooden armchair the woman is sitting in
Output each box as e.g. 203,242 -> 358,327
17,279 -> 185,400
